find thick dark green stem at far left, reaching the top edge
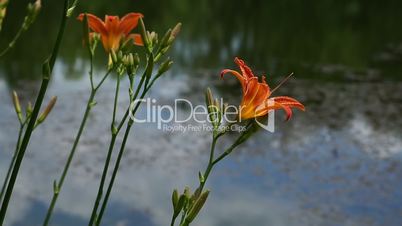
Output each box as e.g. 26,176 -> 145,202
0,0 -> 69,222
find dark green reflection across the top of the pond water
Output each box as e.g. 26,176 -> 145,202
0,0 -> 402,84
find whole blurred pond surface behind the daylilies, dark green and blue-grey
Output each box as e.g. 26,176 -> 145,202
0,0 -> 402,226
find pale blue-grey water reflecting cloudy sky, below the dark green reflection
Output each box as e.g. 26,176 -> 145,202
0,64 -> 402,226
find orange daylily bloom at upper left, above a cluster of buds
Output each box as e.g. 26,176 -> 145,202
77,13 -> 144,52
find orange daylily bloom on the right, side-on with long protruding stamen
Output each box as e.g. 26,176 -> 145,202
221,57 -> 305,121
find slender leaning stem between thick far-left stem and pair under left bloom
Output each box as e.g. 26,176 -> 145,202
43,90 -> 96,226
